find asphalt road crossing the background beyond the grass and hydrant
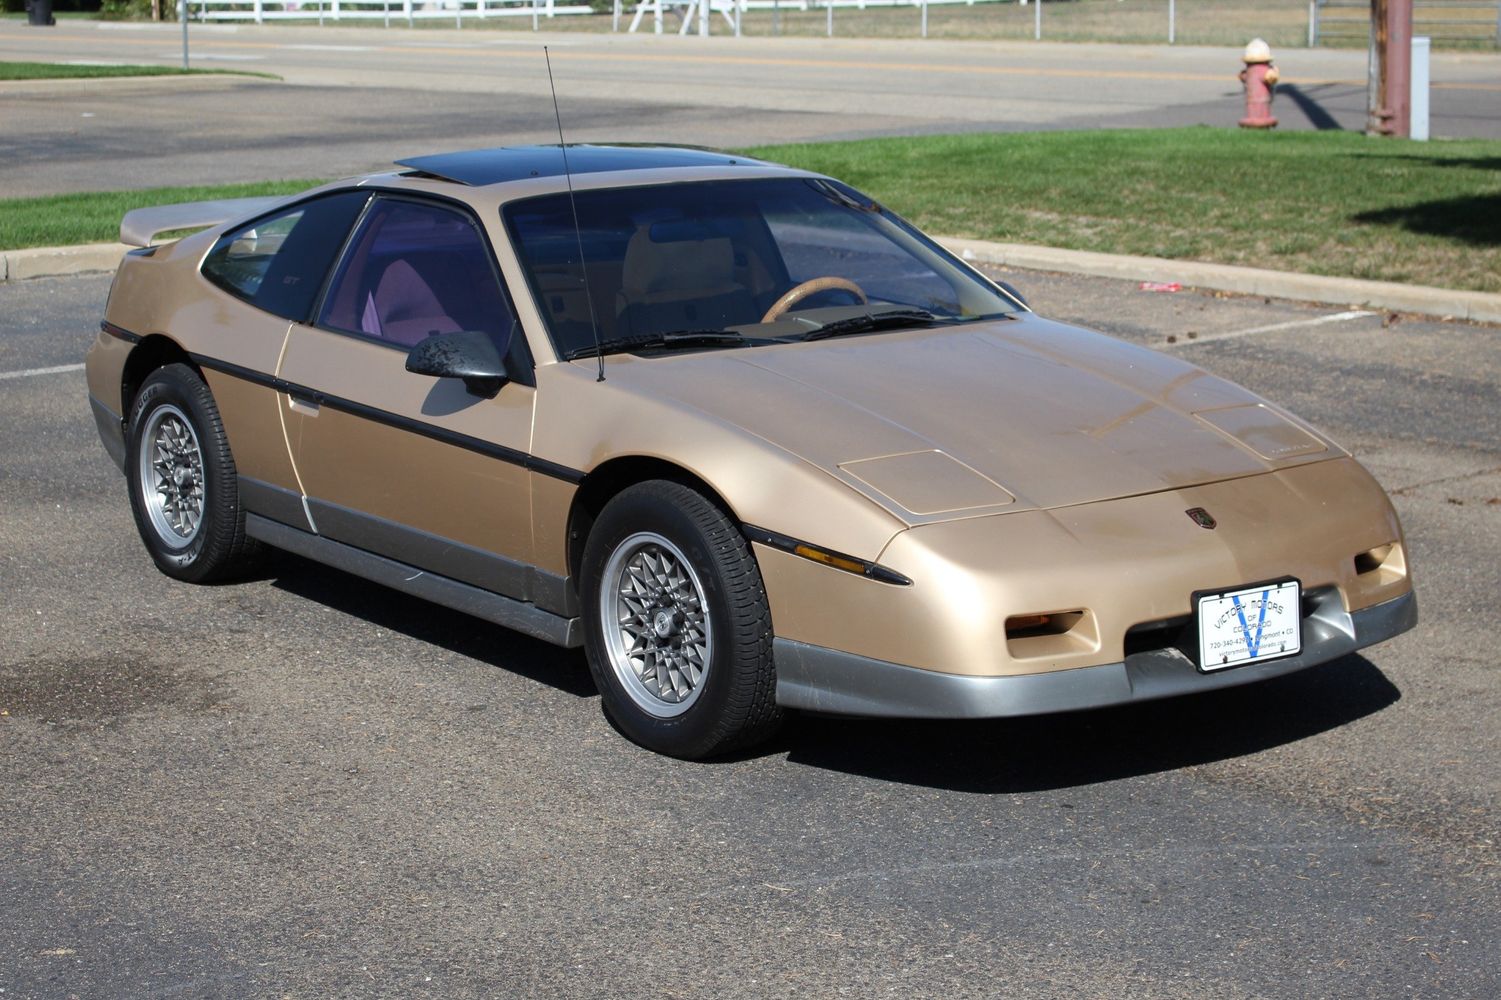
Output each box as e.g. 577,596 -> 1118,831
0,21 -> 1501,197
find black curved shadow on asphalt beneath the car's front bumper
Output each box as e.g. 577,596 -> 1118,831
761,655 -> 1402,793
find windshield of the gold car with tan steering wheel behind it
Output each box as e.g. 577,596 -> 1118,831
504,177 -> 1018,357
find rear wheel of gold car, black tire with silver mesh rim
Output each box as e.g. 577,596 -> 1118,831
125,365 -> 261,583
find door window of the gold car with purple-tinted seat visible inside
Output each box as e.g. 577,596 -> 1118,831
318,198 -> 513,351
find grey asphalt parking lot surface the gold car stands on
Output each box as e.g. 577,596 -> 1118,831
0,273 -> 1501,1000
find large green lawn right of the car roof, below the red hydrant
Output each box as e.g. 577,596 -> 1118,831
746,128 -> 1501,291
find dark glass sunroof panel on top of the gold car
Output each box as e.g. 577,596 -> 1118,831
396,143 -> 761,186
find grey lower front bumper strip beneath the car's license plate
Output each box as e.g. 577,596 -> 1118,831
775,590 -> 1417,719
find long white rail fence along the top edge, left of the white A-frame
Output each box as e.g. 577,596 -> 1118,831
188,0 -> 591,24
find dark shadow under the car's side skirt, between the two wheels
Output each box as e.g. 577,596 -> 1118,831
260,553 -> 599,698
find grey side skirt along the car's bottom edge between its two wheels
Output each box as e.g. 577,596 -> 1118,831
245,514 -> 584,647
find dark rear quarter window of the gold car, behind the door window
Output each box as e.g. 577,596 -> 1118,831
203,191 -> 369,321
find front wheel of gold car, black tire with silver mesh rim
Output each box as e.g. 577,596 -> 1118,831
581,480 -> 782,760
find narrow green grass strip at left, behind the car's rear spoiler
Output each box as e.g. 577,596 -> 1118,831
0,180 -> 321,249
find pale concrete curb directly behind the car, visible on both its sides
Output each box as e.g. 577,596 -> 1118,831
0,237 -> 1501,323
